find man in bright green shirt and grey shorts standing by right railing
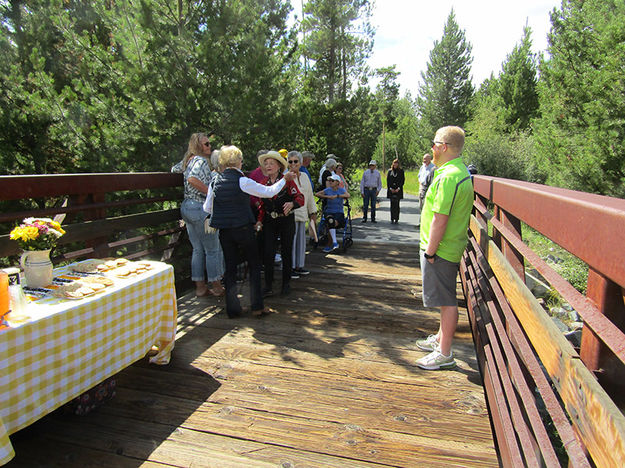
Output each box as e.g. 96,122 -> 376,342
417,126 -> 473,370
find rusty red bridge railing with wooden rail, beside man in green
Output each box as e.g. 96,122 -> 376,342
461,176 -> 625,466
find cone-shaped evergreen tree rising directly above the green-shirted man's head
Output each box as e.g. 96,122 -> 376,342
417,9 -> 473,138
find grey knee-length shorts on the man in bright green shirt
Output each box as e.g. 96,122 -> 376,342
420,250 -> 460,307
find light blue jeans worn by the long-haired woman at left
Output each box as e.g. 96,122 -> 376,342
180,198 -> 224,283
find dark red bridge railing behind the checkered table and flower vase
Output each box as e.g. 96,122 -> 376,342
0,173 -> 188,279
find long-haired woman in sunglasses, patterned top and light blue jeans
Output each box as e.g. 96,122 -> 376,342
171,133 -> 224,297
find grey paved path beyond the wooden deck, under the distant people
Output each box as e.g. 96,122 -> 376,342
352,189 -> 420,247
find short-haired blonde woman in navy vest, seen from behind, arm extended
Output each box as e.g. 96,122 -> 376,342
204,146 -> 295,318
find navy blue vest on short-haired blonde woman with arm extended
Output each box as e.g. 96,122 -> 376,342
210,168 -> 256,229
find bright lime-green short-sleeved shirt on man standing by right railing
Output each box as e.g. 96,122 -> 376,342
419,157 -> 473,263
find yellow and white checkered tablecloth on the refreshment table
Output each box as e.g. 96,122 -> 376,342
0,262 -> 177,465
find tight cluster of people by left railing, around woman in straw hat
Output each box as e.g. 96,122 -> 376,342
171,139 -> 349,318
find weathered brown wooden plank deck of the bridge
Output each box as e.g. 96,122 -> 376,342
7,245 -> 498,468
